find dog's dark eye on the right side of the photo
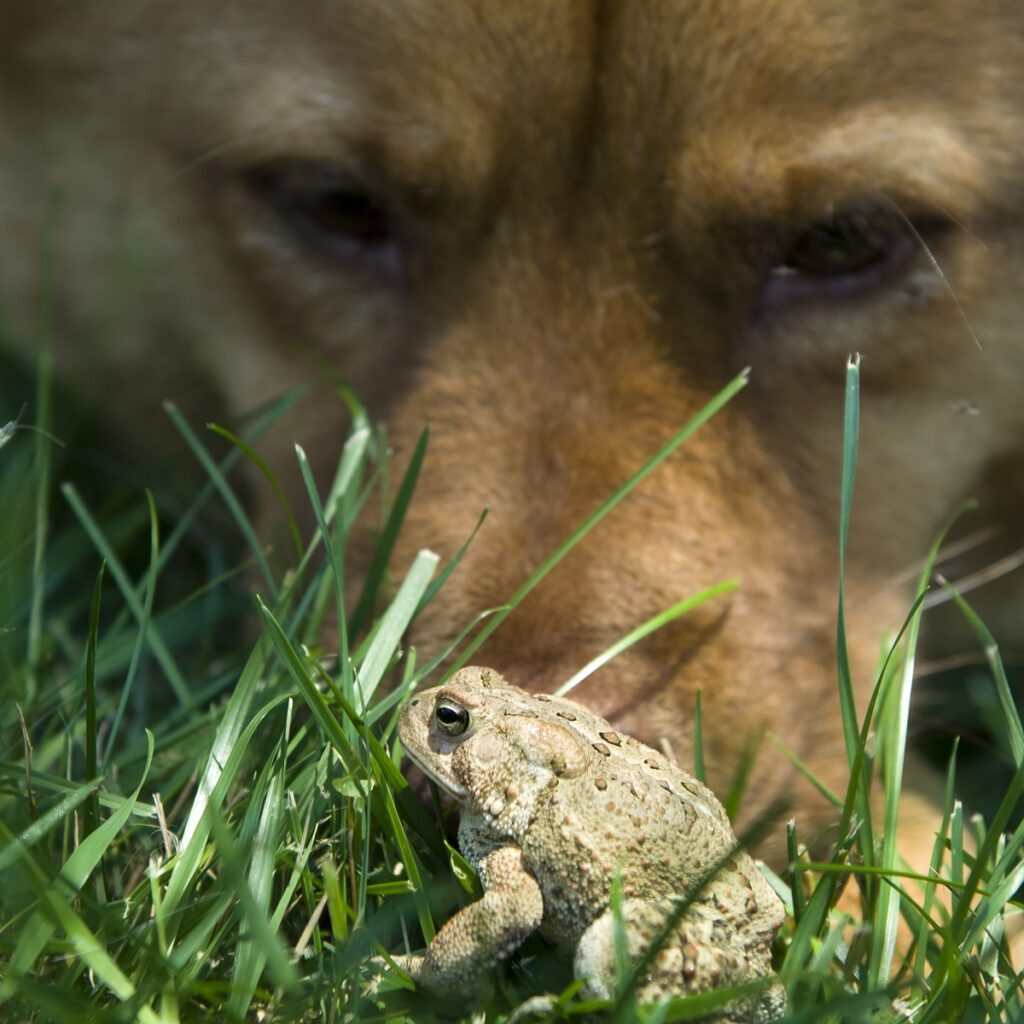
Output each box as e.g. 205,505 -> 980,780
765,199 -> 921,306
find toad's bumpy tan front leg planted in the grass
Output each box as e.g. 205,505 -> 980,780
395,847 -> 544,992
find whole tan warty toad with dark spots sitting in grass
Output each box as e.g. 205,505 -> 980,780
398,668 -> 785,1022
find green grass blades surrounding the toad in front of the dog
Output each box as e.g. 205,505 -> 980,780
0,354 -> 1024,1024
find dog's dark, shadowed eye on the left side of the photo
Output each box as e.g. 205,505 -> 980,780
247,161 -> 402,276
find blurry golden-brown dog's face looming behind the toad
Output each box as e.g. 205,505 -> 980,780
0,0 -> 1024,864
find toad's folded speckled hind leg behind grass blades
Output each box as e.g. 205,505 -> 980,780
573,899 -> 784,1024
